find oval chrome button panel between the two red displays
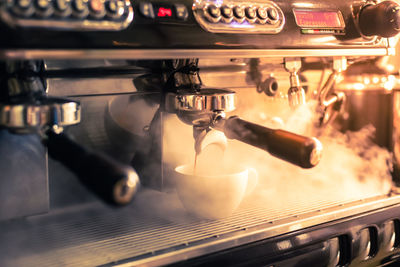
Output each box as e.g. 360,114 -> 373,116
193,0 -> 285,34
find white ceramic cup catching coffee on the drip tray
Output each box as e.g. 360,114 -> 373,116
175,165 -> 258,219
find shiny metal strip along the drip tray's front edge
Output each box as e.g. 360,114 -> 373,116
113,195 -> 400,267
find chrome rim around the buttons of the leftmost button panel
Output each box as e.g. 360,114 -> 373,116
0,0 -> 134,31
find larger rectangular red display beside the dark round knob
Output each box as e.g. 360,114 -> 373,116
293,10 -> 344,28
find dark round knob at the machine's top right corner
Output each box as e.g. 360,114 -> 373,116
359,1 -> 400,37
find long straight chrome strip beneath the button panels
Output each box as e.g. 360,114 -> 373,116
0,47 -> 390,60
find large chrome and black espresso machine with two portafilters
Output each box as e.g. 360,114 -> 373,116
0,0 -> 400,266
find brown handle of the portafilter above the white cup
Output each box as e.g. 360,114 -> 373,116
217,116 -> 322,168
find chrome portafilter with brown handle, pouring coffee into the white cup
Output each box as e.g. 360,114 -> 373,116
165,88 -> 322,168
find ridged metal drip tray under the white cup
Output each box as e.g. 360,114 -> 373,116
0,191 -> 400,267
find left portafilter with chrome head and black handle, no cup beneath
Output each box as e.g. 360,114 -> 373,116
0,96 -> 140,205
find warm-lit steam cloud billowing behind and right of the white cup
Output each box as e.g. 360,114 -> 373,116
158,92 -> 392,220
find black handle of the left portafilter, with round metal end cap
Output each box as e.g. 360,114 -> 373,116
45,130 -> 140,205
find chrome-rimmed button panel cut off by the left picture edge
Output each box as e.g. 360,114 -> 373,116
0,0 -> 134,31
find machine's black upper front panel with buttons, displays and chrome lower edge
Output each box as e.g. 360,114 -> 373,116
0,0 -> 397,59
